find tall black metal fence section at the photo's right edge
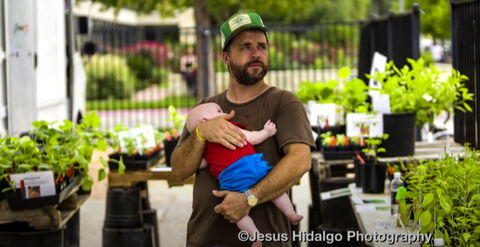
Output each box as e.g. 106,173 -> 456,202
451,0 -> 480,149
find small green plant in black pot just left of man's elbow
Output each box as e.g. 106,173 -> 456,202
163,105 -> 187,166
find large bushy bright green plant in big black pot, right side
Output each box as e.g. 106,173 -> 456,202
367,58 -> 473,157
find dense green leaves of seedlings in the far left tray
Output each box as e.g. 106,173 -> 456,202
0,112 -> 107,191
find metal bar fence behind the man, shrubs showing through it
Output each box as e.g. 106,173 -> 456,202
79,21 -> 360,129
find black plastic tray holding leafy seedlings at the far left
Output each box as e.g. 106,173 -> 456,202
6,174 -> 82,210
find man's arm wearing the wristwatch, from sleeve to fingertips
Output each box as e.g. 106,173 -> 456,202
214,143 -> 311,223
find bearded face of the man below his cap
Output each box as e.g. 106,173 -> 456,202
226,30 -> 268,86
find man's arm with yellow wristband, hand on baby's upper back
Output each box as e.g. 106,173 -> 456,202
171,111 -> 247,181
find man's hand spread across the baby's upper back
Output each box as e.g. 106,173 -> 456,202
198,111 -> 247,150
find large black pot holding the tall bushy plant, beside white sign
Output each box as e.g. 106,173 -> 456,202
378,113 -> 416,157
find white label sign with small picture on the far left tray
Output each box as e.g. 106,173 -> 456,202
10,171 -> 56,199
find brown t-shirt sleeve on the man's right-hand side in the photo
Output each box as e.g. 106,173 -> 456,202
275,91 -> 316,152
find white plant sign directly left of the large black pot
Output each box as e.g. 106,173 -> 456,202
347,113 -> 383,137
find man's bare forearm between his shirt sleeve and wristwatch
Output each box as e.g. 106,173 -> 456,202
251,143 -> 311,203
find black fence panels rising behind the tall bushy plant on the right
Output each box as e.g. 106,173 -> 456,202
358,4 -> 420,83
